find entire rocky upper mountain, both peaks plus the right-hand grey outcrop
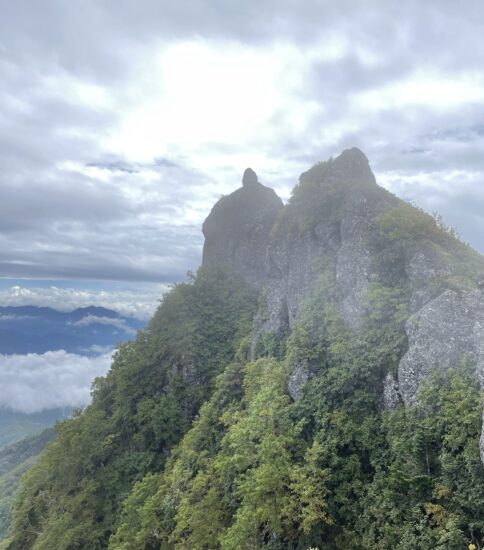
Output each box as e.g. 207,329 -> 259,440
203,149 -> 484,458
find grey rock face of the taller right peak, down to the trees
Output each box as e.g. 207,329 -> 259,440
253,149 -> 398,349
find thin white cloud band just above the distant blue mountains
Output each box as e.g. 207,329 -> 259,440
0,284 -> 168,321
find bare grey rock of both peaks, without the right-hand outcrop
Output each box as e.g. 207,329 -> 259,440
203,149 -> 398,396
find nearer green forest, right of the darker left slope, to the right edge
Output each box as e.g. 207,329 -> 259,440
110,272 -> 484,550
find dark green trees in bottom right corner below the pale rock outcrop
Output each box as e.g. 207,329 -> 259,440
360,364 -> 484,549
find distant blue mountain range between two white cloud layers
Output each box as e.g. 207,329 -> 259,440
0,306 -> 145,356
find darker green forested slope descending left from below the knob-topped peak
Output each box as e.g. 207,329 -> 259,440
8,268 -> 256,550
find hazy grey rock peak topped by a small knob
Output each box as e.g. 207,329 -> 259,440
202,168 -> 283,288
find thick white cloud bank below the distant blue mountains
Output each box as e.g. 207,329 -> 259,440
0,350 -> 111,413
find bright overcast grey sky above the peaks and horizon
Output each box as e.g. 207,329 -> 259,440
0,0 -> 484,305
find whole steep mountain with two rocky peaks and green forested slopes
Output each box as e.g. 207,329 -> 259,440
2,149 -> 484,550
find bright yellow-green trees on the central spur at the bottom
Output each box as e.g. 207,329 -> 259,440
110,359 -> 331,550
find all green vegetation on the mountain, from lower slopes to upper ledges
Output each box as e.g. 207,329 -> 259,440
0,176 -> 484,550
